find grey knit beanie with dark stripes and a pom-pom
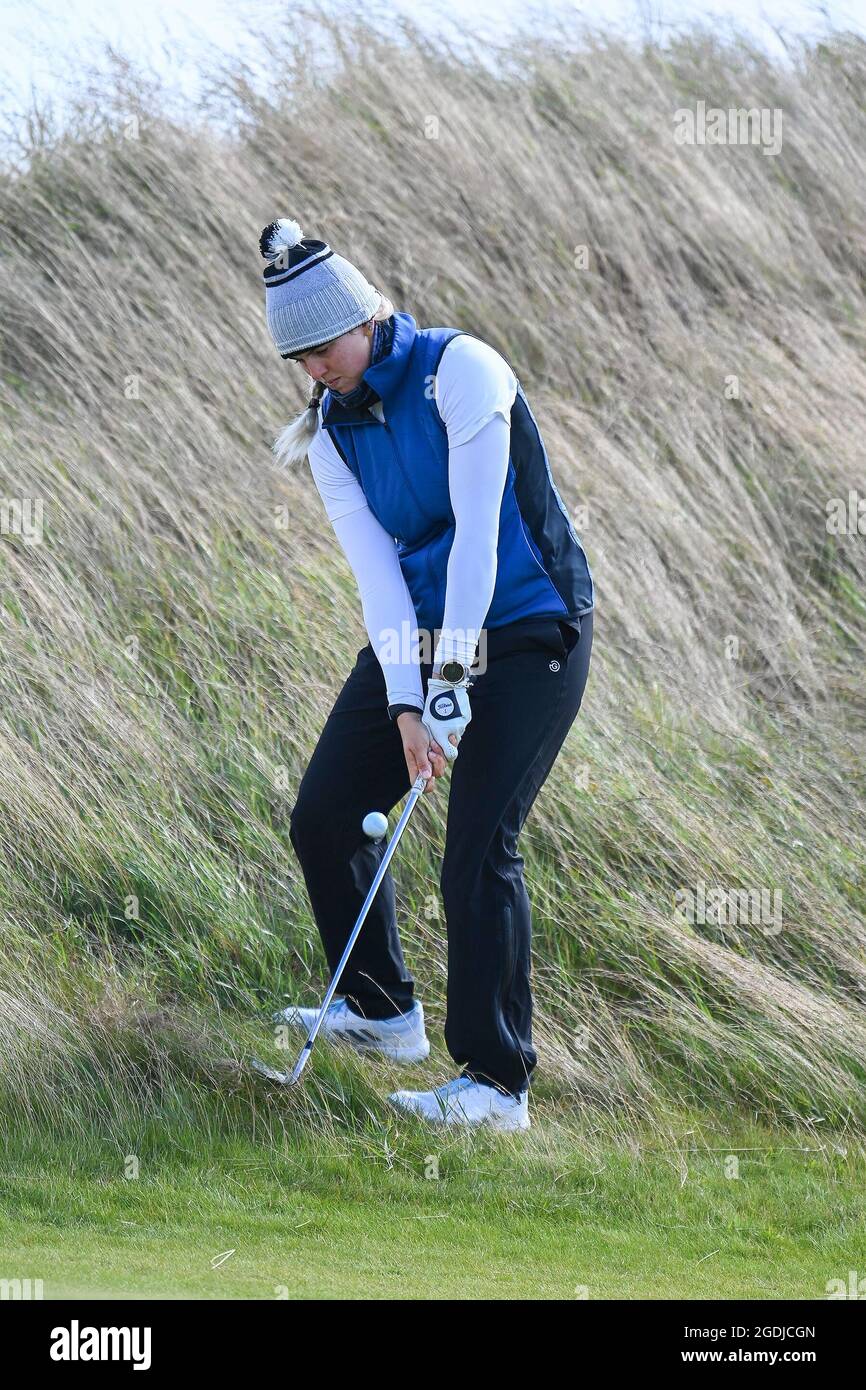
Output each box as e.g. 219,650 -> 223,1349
259,217 -> 381,357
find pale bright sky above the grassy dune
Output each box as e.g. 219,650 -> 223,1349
0,0 -> 866,132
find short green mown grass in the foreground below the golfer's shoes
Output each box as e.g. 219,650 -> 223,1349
0,1102 -> 866,1300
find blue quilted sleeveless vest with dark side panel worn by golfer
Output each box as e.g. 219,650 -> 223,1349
322,313 -> 595,634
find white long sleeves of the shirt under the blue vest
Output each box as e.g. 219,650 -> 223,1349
309,335 -> 517,709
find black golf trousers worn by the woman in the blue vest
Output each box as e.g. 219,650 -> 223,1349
291,613 -> 592,1095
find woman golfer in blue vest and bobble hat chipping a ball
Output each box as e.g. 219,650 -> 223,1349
260,218 -> 594,1130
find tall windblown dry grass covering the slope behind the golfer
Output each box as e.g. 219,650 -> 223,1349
0,13 -> 866,1126
